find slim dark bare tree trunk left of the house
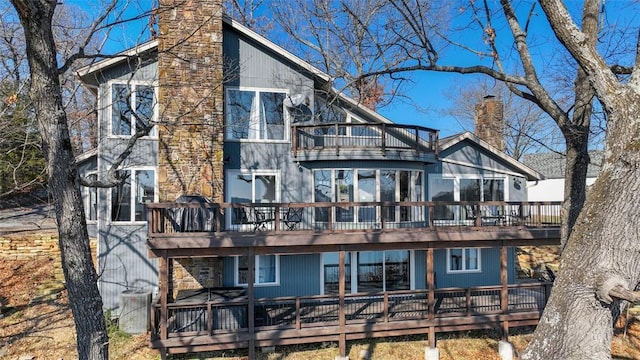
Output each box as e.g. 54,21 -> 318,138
11,0 -> 108,360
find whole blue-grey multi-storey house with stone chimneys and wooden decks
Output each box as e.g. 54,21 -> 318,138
78,1 -> 559,356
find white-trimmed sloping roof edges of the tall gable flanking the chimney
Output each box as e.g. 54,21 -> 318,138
76,15 -> 392,123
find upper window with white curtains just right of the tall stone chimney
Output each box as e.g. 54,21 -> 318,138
225,89 -> 287,140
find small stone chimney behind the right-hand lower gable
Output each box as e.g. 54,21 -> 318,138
475,95 -> 506,151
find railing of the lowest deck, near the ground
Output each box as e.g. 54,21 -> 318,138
152,283 -> 551,337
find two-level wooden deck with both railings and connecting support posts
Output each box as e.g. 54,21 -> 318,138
148,202 -> 560,358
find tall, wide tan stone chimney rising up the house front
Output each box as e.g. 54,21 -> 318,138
158,0 -> 224,202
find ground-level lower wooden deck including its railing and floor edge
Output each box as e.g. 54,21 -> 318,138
152,283 -> 551,353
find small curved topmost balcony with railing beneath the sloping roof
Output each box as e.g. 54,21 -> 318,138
292,123 -> 438,163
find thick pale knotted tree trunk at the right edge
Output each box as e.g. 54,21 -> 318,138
523,93 -> 640,360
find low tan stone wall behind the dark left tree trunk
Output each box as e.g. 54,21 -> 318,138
0,230 -> 98,281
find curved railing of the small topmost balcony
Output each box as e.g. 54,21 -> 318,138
293,123 -> 438,156
